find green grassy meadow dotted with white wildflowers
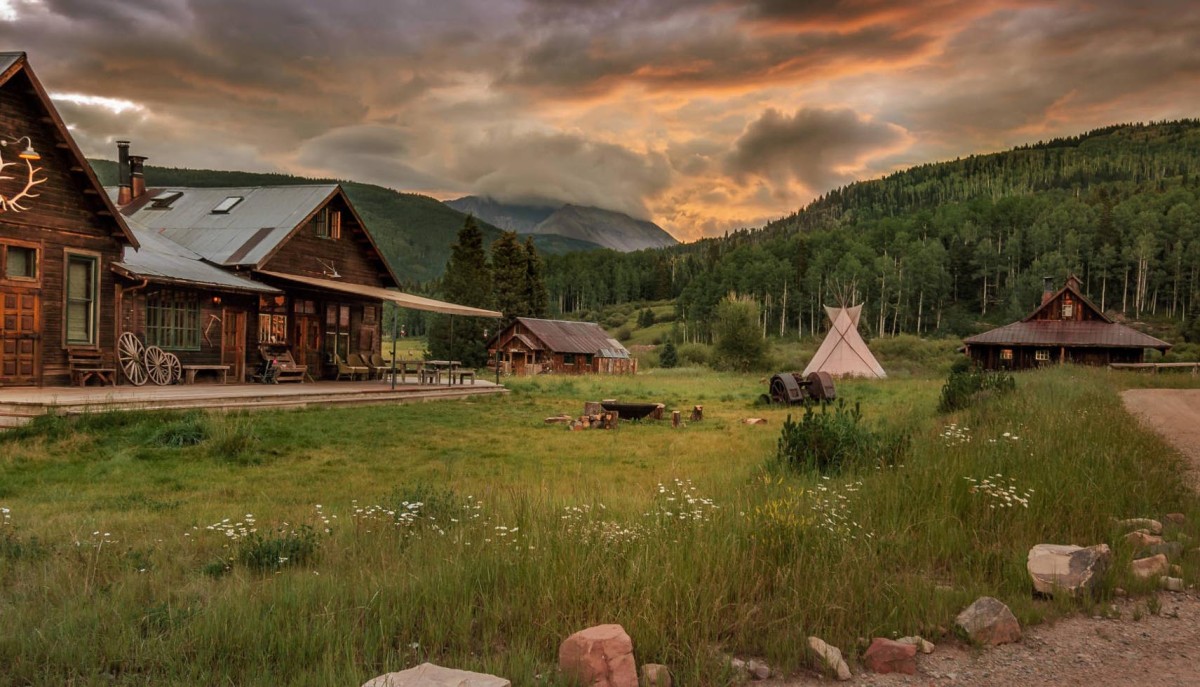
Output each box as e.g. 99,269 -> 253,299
0,367 -> 1200,686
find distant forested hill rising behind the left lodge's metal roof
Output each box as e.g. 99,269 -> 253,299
90,160 -> 595,282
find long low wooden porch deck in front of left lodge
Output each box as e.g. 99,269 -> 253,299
0,376 -> 508,430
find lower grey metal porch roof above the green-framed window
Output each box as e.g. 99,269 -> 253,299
115,221 -> 280,293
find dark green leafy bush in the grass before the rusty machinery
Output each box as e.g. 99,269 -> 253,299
775,401 -> 911,473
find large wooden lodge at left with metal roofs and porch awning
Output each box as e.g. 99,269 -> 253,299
0,53 -> 499,387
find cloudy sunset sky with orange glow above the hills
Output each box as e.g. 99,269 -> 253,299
0,0 -> 1200,240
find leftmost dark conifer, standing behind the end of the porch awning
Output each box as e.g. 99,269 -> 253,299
430,215 -> 494,368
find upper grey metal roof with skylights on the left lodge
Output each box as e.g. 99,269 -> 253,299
106,184 -> 337,265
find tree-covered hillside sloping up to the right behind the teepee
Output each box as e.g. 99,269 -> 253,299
547,120 -> 1200,340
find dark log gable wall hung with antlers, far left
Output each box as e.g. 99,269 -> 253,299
0,72 -> 125,386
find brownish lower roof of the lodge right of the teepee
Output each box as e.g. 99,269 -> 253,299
962,319 -> 1171,350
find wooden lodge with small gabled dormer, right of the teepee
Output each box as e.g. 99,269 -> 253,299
964,276 -> 1171,370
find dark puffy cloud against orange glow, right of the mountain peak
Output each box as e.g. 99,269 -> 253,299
728,108 -> 905,191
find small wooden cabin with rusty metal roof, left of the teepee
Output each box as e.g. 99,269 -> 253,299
488,317 -> 637,375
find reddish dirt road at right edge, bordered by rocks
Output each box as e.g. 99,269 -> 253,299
760,389 -> 1200,687
